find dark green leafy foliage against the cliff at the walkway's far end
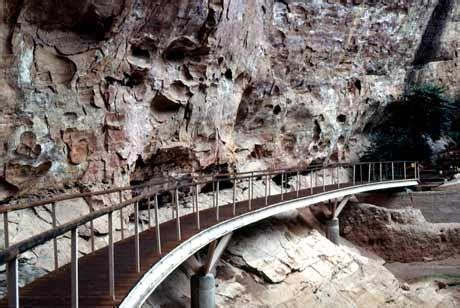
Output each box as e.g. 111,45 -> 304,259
362,84 -> 460,161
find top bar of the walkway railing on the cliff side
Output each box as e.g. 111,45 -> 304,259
0,161 -> 416,214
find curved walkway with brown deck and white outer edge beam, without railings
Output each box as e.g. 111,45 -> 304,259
0,163 -> 418,307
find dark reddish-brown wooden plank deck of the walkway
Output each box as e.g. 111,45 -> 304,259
0,184 -> 352,308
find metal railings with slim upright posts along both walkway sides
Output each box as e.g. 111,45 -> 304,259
0,161 -> 420,307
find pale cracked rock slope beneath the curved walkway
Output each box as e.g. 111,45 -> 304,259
144,213 -> 457,308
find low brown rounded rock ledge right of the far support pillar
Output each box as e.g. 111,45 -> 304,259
340,203 -> 460,262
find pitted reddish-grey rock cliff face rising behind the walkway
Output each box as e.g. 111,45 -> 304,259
0,0 -> 460,199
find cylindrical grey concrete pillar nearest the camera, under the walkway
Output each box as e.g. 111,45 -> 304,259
191,274 -> 216,308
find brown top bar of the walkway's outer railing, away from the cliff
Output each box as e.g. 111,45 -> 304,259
0,162 -> 418,264
